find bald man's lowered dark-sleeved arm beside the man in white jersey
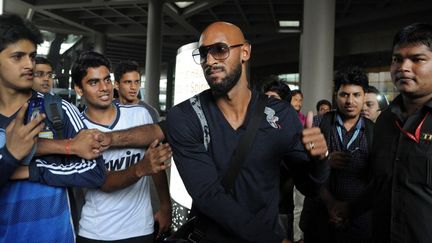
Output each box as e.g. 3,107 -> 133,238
167,106 -> 283,243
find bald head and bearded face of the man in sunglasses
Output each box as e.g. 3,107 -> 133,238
199,22 -> 250,96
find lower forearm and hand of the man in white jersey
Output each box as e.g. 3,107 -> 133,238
100,140 -> 171,192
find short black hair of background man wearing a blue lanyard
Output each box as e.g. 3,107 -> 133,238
334,66 -> 369,93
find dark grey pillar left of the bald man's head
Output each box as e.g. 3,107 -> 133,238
144,0 -> 163,107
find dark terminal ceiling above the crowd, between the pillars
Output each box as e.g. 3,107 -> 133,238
5,0 -> 432,71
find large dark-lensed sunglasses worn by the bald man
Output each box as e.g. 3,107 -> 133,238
192,43 -> 245,64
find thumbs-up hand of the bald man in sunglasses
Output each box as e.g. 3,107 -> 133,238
302,111 -> 328,159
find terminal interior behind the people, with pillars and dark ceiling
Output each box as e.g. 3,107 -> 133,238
0,0 -> 432,113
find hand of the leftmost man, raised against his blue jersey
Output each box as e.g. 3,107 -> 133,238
6,102 -> 45,160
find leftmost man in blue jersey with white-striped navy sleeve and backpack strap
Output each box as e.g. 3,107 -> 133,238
0,15 -> 106,242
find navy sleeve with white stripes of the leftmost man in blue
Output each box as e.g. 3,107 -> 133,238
29,100 -> 106,188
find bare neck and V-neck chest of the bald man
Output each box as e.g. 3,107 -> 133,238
216,78 -> 252,130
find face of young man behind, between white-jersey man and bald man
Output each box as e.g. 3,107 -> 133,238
115,71 -> 141,104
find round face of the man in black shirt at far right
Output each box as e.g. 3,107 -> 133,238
390,44 -> 432,99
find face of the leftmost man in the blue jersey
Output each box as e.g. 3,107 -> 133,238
0,39 -> 36,91
